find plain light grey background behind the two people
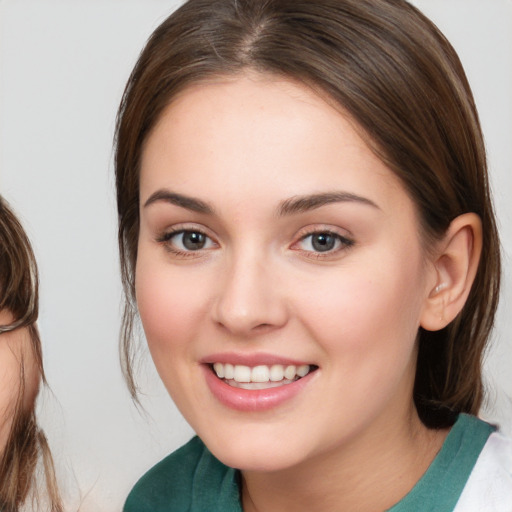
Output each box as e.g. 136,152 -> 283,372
0,0 -> 512,512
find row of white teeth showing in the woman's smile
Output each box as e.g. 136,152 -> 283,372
213,363 -> 311,383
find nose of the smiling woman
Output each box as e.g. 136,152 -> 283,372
213,251 -> 288,337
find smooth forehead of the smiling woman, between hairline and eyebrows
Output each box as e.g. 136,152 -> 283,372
141,74 -> 414,218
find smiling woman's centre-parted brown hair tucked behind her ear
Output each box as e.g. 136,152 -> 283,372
115,0 -> 500,427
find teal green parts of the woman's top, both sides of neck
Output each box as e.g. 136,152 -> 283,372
124,414 -> 494,512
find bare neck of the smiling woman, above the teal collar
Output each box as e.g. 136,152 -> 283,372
242,407 -> 448,512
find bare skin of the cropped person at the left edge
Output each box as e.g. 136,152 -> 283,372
0,311 -> 40,453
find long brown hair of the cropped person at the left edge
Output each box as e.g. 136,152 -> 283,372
0,197 -> 62,512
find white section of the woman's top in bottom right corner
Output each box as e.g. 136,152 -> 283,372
455,426 -> 512,512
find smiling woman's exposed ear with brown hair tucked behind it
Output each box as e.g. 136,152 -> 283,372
420,213 -> 482,331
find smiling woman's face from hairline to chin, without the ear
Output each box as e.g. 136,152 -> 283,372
136,75 -> 436,471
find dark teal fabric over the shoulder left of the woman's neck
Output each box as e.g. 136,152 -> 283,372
123,437 -> 238,512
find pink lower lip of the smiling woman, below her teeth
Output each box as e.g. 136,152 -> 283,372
203,365 -> 316,412
